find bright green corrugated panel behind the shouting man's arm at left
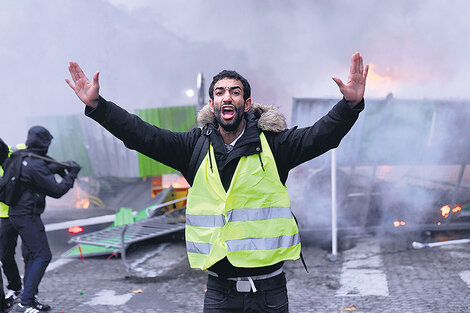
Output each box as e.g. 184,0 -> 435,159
136,105 -> 196,177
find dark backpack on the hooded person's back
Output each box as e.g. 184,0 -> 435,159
0,150 -> 26,206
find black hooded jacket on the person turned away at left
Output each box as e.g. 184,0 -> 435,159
9,126 -> 74,216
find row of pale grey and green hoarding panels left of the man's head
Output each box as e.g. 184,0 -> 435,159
26,106 -> 196,178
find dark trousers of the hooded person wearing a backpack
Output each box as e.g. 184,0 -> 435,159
10,215 -> 52,305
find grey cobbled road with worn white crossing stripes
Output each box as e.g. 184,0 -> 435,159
12,227 -> 470,313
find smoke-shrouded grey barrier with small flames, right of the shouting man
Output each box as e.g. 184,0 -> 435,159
288,94 -> 470,241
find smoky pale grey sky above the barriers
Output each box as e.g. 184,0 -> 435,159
0,0 -> 470,144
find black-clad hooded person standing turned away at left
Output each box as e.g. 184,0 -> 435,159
9,126 -> 81,312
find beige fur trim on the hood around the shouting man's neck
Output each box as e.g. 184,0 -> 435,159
197,102 -> 287,133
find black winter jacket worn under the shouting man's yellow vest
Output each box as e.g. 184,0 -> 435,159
85,97 -> 364,277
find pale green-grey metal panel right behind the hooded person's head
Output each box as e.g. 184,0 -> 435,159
27,115 -> 93,176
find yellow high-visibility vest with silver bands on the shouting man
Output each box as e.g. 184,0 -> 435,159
186,133 -> 300,270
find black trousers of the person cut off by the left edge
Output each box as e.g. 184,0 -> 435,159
0,217 -> 29,291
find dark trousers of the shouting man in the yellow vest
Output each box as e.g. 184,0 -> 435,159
204,273 -> 289,313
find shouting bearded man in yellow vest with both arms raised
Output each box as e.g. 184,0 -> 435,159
66,53 -> 368,312
